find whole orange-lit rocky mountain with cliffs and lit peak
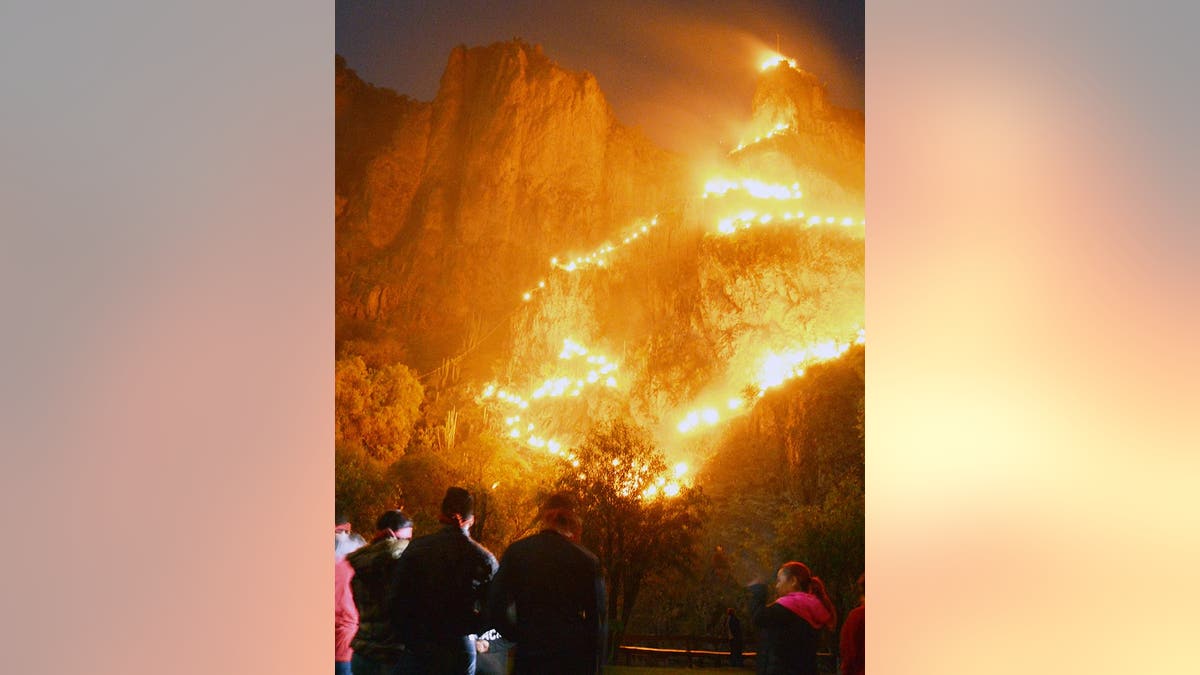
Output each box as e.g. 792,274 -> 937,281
336,40 -> 864,426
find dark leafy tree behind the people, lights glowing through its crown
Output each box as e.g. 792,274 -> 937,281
558,419 -> 707,645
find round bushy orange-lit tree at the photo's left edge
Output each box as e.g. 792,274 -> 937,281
335,356 -> 425,462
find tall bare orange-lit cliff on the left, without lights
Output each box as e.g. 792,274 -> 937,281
337,41 -> 685,366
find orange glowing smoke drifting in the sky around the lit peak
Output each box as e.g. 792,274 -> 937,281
547,0 -> 864,159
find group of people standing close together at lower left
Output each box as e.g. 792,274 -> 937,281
335,488 -> 606,675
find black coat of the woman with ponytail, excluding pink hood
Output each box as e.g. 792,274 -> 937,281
750,584 -> 820,675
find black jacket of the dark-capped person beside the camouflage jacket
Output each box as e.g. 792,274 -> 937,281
390,526 -> 497,650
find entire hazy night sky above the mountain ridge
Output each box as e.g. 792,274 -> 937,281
336,0 -> 864,154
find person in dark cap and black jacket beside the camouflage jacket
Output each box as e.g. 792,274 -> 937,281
389,488 -> 497,675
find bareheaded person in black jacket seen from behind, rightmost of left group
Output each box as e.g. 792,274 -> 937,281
487,492 -> 606,675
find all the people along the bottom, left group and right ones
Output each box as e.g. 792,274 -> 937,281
334,488 -> 864,675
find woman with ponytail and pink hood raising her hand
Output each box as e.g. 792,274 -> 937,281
750,562 -> 838,675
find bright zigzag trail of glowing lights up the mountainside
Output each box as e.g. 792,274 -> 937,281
478,54 -> 866,500
